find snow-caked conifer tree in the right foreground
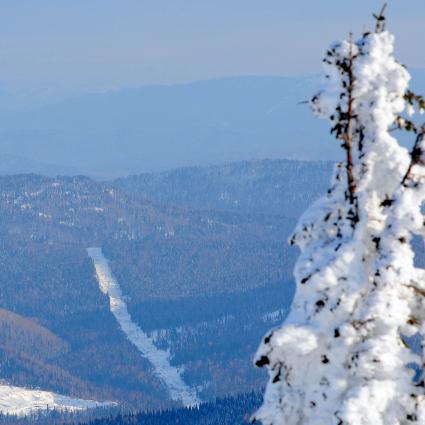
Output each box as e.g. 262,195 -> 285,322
254,7 -> 425,425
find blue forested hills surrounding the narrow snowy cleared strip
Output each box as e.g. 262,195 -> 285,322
0,161 -> 329,409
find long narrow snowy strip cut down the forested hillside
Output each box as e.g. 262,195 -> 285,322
87,248 -> 200,406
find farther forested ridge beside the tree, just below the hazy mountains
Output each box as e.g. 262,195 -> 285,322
113,159 -> 332,219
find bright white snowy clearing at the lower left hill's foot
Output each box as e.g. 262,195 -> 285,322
0,385 -> 114,416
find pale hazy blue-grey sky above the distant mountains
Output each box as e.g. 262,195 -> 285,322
0,0 -> 425,98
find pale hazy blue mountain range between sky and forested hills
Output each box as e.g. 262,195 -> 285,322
0,77 -> 338,177
